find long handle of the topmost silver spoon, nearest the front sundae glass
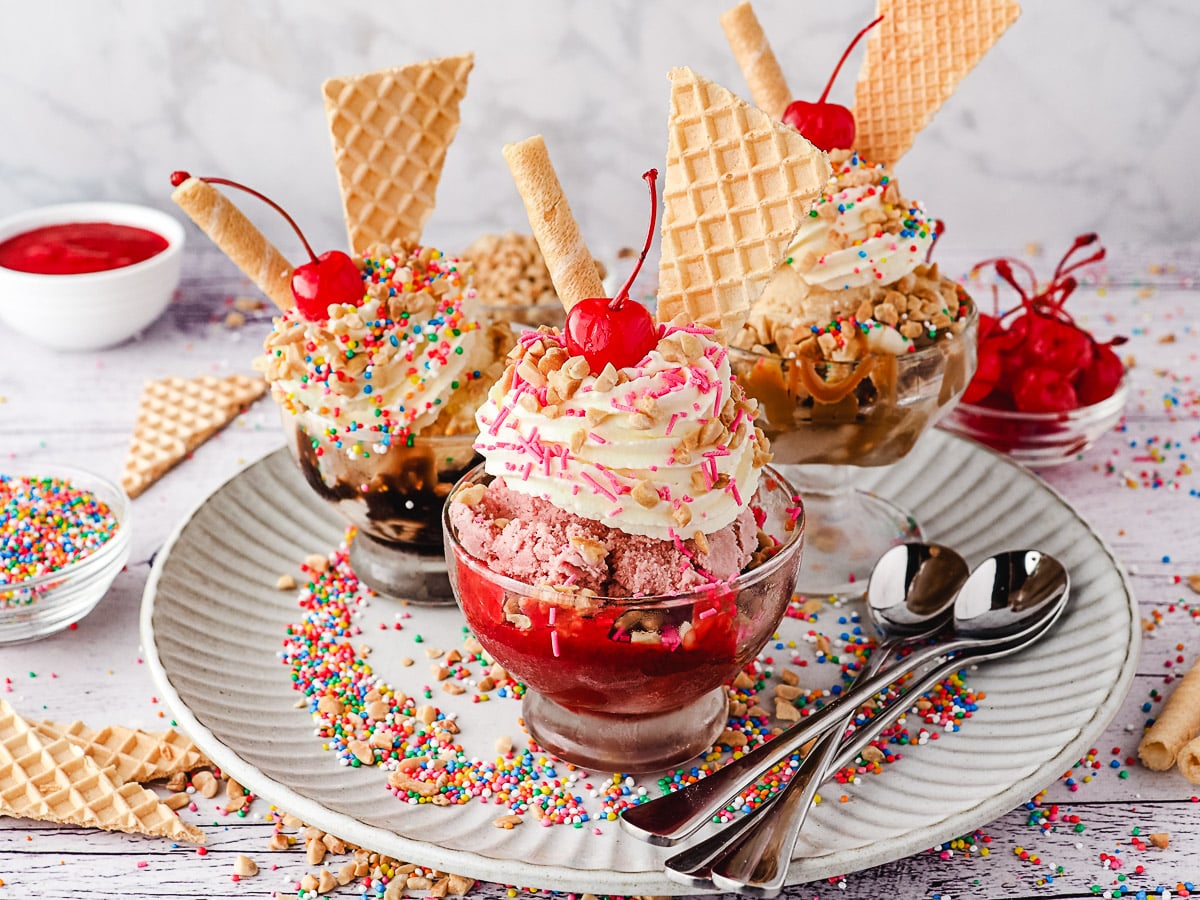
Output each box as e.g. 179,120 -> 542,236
620,642 -> 953,846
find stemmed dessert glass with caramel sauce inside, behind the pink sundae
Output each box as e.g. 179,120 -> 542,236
730,296 -> 978,595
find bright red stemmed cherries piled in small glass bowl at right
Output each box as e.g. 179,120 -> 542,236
962,234 -> 1124,413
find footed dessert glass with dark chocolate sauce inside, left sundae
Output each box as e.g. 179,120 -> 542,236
281,410 -> 479,604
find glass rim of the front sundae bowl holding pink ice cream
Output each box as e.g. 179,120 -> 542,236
442,463 -> 804,610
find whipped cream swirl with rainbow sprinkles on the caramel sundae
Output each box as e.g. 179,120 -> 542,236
788,151 -> 938,290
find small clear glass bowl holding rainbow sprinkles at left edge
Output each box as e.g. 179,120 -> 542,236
0,464 -> 132,643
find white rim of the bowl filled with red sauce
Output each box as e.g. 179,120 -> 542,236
0,200 -> 185,283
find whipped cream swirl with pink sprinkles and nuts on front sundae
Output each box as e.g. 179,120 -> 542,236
475,326 -> 770,541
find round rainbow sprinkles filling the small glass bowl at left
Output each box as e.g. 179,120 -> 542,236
0,474 -> 120,596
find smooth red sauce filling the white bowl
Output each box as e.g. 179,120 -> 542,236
0,222 -> 167,275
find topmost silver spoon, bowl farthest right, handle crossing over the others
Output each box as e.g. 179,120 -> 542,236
622,551 -> 1068,859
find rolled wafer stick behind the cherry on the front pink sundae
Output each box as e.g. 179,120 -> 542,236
504,134 -> 605,310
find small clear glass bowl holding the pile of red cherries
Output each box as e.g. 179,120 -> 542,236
941,377 -> 1129,468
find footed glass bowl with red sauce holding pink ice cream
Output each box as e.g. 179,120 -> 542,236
443,466 -> 804,772
